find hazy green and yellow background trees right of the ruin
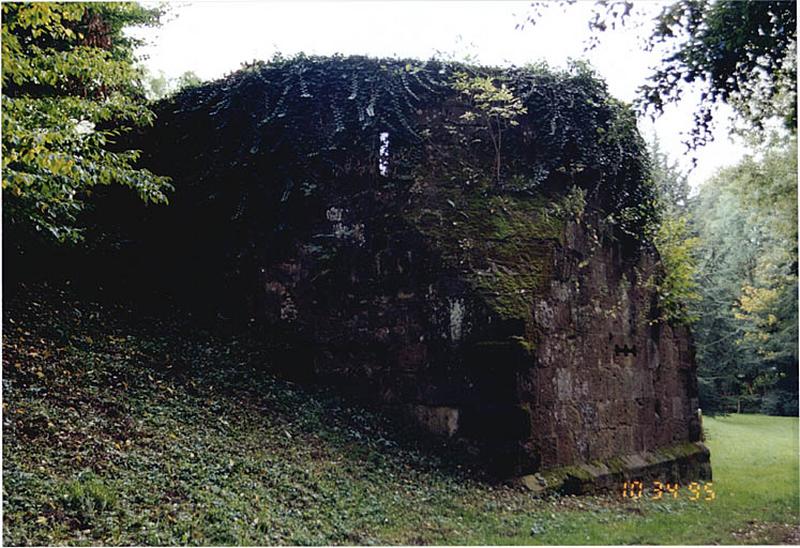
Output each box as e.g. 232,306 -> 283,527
692,139 -> 797,416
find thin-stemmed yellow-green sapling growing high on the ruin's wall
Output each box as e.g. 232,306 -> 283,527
453,72 -> 528,186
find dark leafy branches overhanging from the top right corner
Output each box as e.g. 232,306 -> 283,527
518,0 -> 797,150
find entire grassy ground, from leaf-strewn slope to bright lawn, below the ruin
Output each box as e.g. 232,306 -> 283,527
3,288 -> 800,545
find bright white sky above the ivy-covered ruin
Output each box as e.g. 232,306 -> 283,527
131,0 -> 746,187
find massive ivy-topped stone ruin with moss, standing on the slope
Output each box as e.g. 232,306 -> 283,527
133,58 -> 710,490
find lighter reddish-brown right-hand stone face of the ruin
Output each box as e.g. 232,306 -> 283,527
520,216 -> 701,467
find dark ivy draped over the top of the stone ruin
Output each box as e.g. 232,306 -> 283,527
140,55 -> 655,237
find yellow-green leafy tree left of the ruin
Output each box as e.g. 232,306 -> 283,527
2,3 -> 170,242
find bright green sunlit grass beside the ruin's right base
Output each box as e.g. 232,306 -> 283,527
486,415 -> 800,544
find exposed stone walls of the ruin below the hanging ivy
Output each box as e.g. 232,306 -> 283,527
255,185 -> 710,479
